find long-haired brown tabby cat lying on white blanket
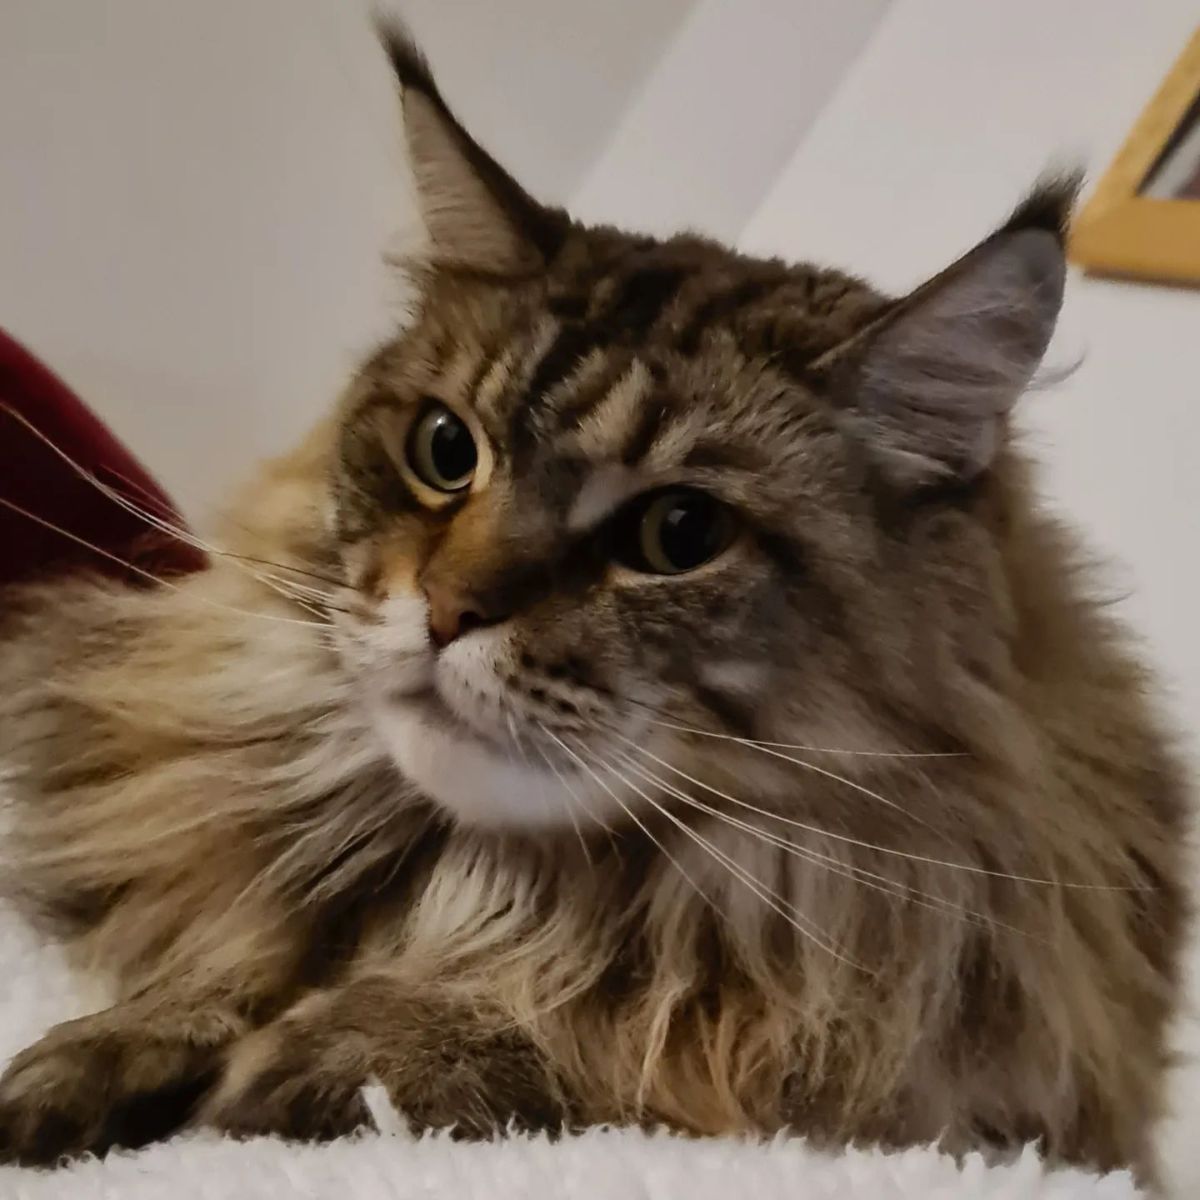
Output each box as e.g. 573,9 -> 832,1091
0,16 -> 1187,1177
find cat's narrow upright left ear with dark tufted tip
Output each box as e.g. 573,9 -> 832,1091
378,19 -> 566,275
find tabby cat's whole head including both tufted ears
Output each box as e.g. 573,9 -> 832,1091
319,34 -> 1072,828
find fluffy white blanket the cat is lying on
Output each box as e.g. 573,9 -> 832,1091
0,888 -> 1139,1200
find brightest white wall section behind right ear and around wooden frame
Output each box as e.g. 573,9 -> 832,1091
742,0 -> 1200,1200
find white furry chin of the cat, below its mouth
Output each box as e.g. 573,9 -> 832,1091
372,691 -> 620,830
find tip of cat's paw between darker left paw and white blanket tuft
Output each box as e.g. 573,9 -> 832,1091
197,1022 -> 372,1141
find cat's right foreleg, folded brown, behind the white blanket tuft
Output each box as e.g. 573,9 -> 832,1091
197,974 -> 570,1139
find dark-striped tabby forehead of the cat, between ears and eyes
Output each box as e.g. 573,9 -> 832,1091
369,229 -> 884,512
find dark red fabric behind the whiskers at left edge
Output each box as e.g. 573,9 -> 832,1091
0,330 -> 204,586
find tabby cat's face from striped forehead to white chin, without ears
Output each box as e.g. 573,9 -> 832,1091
338,232 -> 878,823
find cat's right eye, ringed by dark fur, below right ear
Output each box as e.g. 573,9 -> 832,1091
618,487 -> 737,575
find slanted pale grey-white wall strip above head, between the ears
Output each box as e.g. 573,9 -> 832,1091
571,0 -> 890,240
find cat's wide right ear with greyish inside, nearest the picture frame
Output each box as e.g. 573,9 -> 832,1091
816,179 -> 1079,488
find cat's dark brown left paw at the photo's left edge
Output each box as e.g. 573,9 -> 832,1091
0,1008 -> 239,1166
